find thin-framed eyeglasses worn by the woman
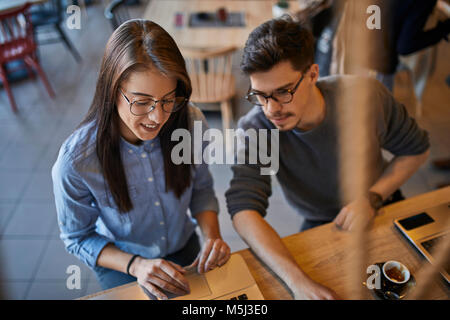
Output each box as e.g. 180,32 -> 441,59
119,89 -> 188,116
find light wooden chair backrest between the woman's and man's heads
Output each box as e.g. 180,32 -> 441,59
181,47 -> 237,102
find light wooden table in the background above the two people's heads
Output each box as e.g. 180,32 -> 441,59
142,0 -> 301,48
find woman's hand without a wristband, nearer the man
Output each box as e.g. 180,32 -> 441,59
187,238 -> 230,273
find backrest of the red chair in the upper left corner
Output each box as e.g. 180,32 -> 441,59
0,4 -> 36,63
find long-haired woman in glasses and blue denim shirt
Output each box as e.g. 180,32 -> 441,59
52,20 -> 230,299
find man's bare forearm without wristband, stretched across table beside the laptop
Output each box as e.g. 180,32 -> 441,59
233,210 -> 308,295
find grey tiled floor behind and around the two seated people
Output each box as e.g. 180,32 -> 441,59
0,1 -> 450,299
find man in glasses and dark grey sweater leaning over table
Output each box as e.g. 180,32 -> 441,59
226,17 -> 429,299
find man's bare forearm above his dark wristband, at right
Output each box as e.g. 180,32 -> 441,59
370,149 -> 430,200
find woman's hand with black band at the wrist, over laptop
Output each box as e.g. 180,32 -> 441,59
130,257 -> 190,300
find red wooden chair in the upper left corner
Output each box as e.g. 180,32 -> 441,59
0,4 -> 55,112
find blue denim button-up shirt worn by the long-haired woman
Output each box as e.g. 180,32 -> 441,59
52,105 -> 219,269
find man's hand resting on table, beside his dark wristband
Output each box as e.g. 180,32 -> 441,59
334,197 -> 376,231
